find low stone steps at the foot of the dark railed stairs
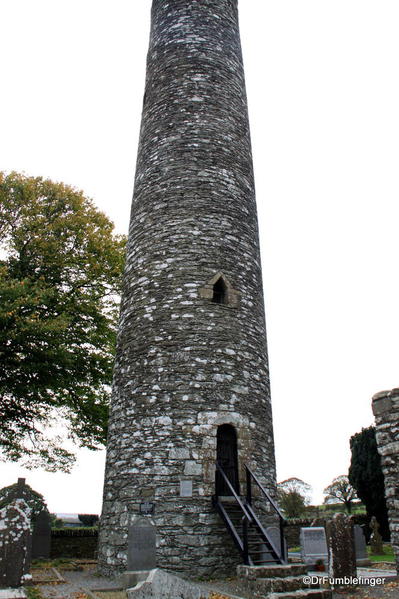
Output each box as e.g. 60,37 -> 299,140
237,564 -> 332,599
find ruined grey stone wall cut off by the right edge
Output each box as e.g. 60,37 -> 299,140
373,389 -> 399,573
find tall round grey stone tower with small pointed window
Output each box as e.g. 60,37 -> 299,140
99,0 -> 276,575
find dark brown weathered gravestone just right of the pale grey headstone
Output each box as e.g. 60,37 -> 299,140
326,514 -> 356,578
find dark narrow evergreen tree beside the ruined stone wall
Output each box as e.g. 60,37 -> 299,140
349,426 -> 389,539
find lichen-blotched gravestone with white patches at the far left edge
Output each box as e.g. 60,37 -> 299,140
0,499 -> 31,587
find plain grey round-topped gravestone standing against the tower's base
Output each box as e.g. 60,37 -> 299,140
127,518 -> 156,572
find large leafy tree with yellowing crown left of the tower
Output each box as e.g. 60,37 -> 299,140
0,173 -> 125,470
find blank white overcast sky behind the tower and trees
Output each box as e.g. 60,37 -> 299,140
0,0 -> 399,513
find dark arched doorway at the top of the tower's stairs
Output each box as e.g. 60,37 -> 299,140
216,424 -> 240,495
